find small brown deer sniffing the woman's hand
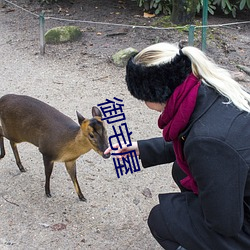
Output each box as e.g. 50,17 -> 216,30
0,94 -> 110,201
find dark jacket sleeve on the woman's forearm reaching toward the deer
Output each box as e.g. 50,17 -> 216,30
138,137 -> 175,168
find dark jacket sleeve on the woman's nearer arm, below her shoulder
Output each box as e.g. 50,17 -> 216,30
184,137 -> 248,237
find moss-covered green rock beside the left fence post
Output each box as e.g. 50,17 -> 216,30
45,26 -> 82,44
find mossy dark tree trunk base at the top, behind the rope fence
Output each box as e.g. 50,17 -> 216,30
171,0 -> 198,25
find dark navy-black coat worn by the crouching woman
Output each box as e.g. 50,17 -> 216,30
138,85 -> 250,249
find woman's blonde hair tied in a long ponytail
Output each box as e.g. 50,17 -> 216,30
134,43 -> 250,113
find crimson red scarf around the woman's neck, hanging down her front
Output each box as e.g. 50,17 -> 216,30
158,73 -> 200,194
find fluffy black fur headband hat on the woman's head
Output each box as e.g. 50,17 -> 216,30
126,51 -> 192,103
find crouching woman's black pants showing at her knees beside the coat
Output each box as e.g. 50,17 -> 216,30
148,162 -> 188,250
